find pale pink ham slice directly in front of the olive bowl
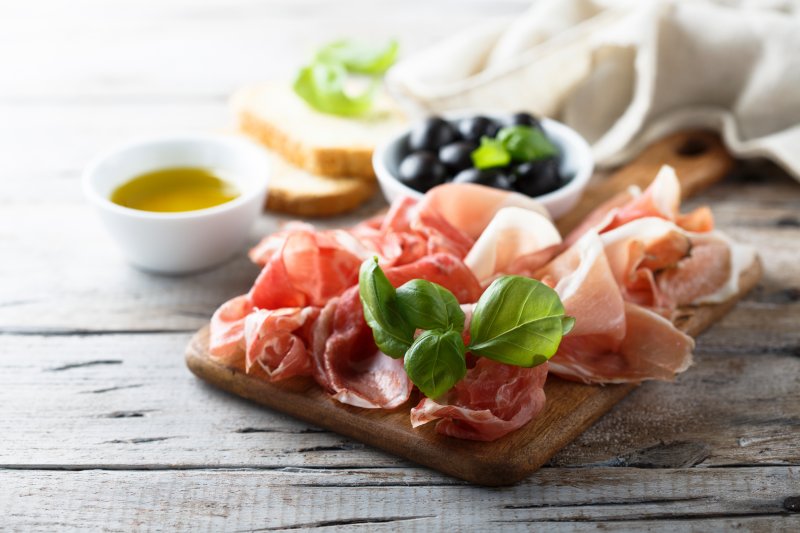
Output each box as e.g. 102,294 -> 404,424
412,183 -> 550,240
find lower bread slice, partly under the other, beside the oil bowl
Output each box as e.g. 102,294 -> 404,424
267,148 -> 377,217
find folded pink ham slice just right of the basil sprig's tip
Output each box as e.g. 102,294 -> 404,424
539,232 -> 694,383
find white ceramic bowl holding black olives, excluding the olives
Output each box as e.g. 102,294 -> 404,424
372,111 -> 594,218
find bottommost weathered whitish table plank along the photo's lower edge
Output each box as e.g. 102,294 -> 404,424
0,467 -> 800,531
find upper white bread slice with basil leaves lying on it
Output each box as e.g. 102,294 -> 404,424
231,81 -> 406,181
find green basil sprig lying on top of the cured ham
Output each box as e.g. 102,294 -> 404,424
359,258 -> 575,398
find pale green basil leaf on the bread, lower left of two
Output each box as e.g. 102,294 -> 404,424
293,62 -> 378,117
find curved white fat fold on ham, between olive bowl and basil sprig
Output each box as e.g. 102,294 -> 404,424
464,207 -> 561,284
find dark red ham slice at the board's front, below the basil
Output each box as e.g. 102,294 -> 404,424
411,357 -> 547,441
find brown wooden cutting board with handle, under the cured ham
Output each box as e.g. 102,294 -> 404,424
186,132 -> 761,485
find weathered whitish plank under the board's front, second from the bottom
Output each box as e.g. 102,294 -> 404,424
0,334 -> 800,470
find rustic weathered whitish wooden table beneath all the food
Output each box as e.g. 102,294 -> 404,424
0,0 -> 800,531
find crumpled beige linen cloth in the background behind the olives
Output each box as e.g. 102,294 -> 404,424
387,0 -> 800,179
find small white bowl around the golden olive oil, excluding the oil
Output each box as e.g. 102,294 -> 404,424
83,134 -> 270,274
